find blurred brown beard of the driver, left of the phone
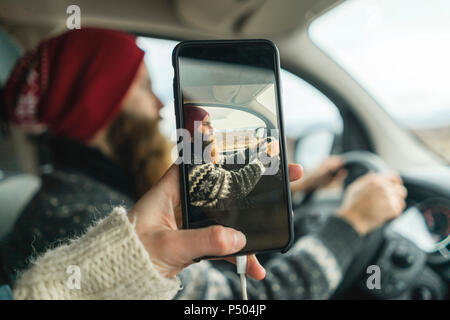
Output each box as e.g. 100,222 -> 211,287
106,110 -> 172,197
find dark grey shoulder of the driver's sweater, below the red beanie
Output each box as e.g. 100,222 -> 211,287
0,138 -> 134,287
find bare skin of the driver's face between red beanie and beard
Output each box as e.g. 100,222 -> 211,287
123,62 -> 163,119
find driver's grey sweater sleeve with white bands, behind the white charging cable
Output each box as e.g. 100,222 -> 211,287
176,217 -> 362,299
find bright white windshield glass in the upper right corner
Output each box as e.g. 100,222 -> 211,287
309,0 -> 450,162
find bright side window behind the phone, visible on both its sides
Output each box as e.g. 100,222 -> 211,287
137,37 -> 343,170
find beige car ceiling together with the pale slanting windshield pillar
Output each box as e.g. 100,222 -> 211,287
0,0 -> 441,168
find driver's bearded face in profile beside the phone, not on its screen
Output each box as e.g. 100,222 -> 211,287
106,63 -> 170,194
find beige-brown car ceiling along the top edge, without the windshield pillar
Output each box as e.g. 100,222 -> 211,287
0,0 -> 342,38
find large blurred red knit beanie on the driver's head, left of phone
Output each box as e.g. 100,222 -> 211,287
5,28 -> 144,141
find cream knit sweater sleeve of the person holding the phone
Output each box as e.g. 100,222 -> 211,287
13,207 -> 180,299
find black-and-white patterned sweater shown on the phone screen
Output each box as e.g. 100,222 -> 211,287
188,159 -> 266,207
